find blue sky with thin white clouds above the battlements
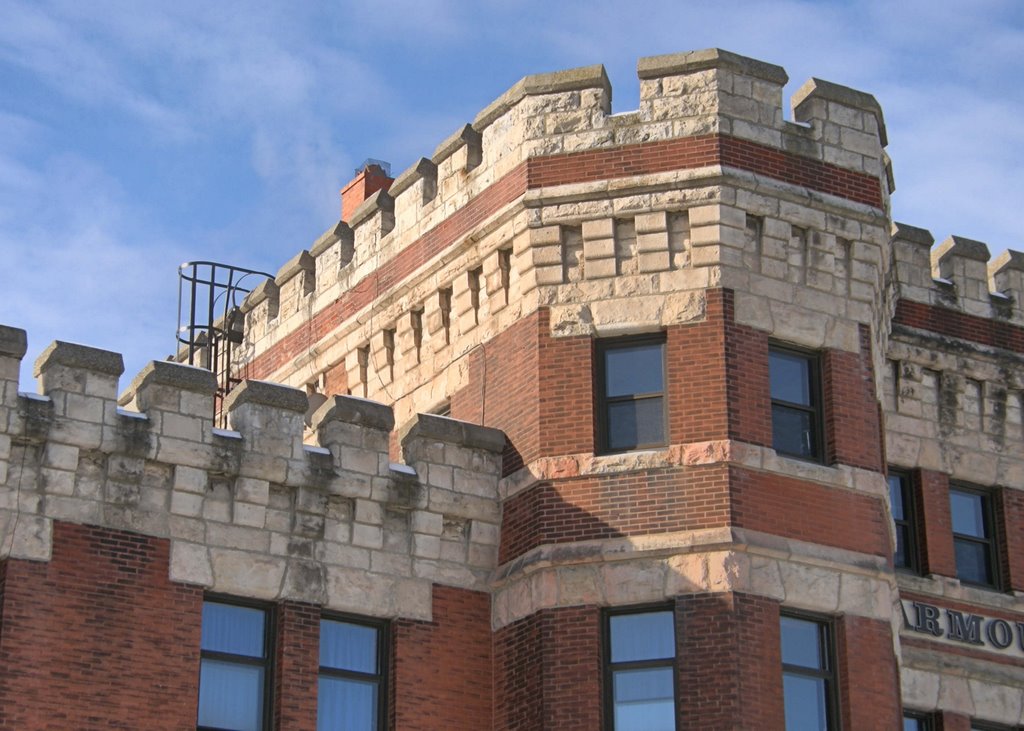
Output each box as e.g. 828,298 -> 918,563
0,0 -> 1024,390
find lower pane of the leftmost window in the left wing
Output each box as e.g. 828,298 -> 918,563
199,659 -> 263,731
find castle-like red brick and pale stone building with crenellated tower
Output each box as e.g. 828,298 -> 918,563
0,50 -> 1024,731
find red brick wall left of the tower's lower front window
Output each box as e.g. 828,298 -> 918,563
493,606 -> 602,731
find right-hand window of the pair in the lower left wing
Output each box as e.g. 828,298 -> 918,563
316,618 -> 387,731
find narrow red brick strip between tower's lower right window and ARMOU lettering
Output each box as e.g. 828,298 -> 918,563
836,615 -> 903,729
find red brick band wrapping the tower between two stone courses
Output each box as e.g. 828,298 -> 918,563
499,465 -> 892,563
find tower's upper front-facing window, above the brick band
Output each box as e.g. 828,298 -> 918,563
597,336 -> 668,452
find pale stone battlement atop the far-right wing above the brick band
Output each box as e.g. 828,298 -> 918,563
892,223 -> 1024,325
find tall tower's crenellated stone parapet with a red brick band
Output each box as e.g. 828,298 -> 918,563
236,49 -> 892,432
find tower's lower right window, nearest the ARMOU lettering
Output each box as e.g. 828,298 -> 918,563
781,615 -> 839,731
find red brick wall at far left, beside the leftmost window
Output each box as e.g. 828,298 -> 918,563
0,522 -> 203,731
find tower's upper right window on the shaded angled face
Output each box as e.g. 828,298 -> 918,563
768,346 -> 823,460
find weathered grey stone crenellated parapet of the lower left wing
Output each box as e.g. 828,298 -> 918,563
0,327 -> 505,618
